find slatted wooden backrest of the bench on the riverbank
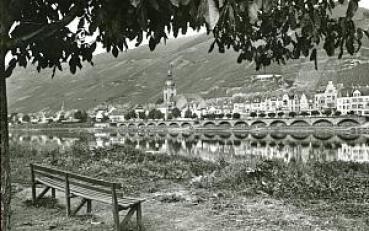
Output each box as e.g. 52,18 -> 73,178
30,164 -> 122,194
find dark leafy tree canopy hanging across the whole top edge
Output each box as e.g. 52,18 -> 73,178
0,0 -> 369,77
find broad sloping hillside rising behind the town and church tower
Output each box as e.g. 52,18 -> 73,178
8,6 -> 369,112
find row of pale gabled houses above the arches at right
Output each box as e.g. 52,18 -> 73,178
233,81 -> 369,115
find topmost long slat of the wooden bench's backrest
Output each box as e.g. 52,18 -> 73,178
32,164 -> 121,189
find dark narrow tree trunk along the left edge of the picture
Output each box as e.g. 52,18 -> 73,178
0,52 -> 11,231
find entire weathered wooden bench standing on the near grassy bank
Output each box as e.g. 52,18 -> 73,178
30,164 -> 144,231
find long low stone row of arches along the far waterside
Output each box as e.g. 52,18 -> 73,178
117,117 -> 366,129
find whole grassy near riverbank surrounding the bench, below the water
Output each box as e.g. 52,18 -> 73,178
11,145 -> 369,231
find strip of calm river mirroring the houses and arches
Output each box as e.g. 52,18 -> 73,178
7,132 -> 369,162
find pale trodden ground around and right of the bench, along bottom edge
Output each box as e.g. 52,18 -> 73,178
12,187 -> 368,231
